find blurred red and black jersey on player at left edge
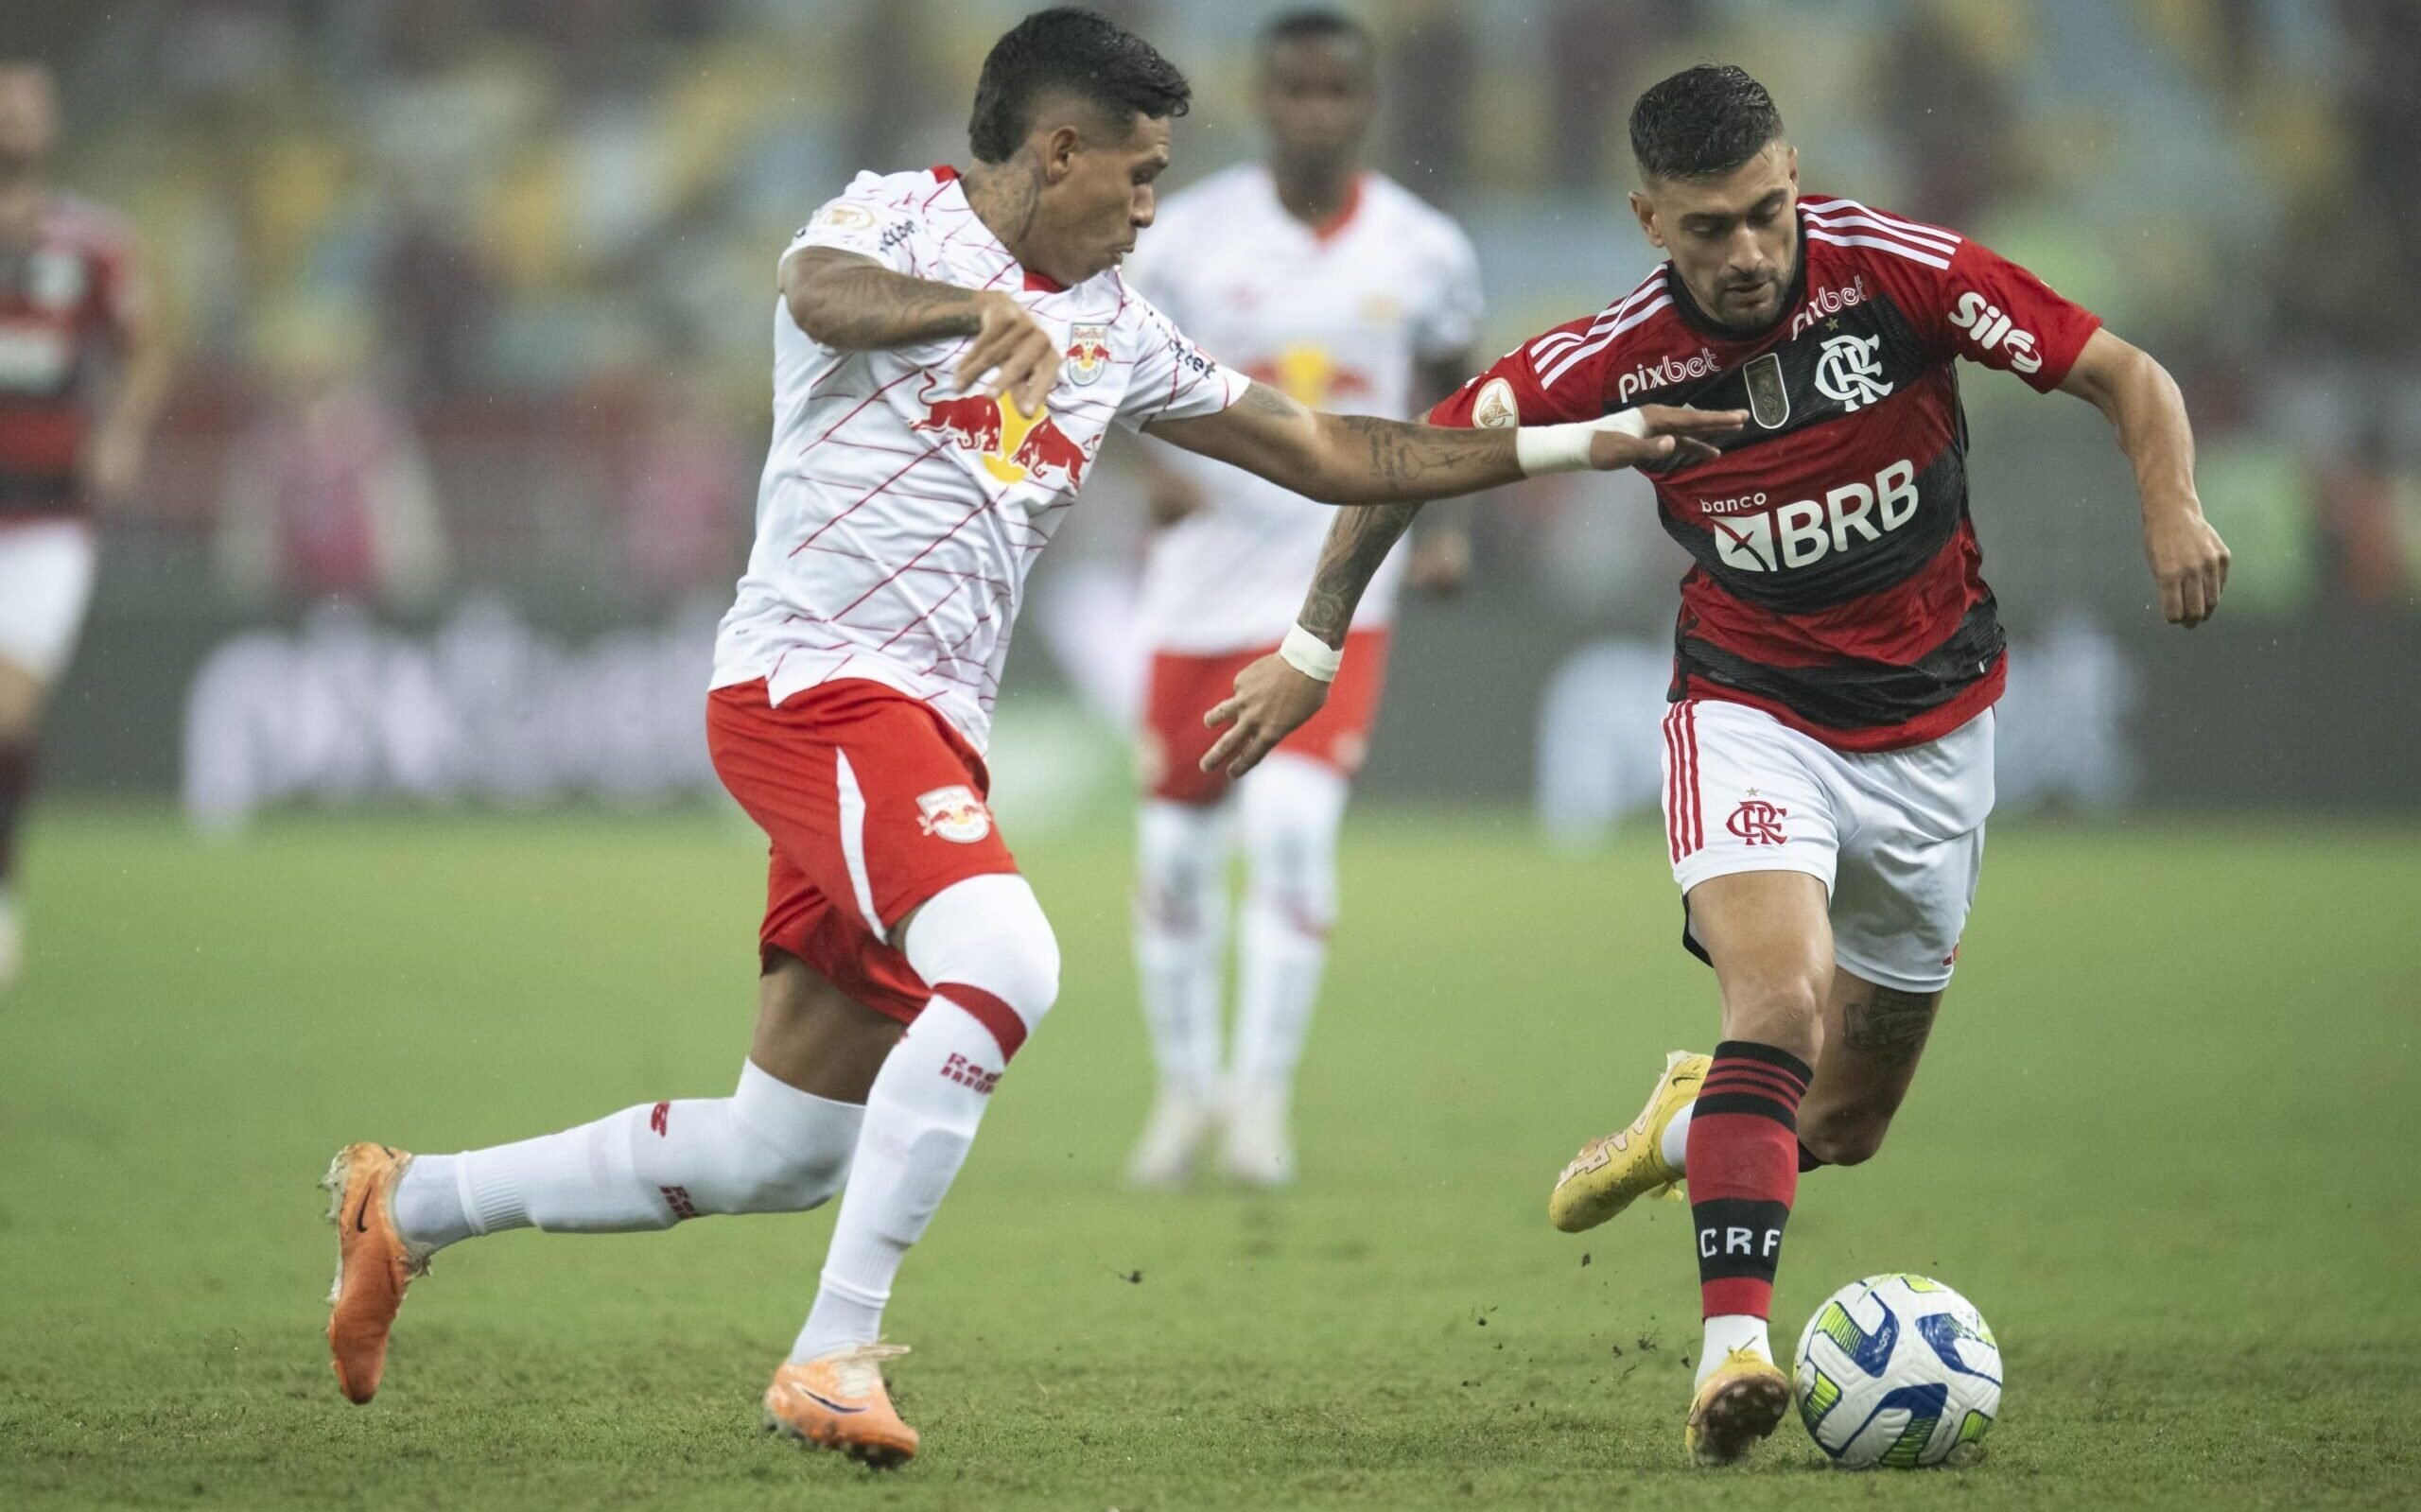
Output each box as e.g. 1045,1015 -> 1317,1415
0,196 -> 140,517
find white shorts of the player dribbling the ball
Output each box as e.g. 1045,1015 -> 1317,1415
1663,699 -> 1993,992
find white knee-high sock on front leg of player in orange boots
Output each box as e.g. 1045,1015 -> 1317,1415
790,874 -> 1058,1362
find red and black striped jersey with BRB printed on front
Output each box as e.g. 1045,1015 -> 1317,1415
1431,199 -> 2101,750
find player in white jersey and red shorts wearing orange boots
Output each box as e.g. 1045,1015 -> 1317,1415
327,8 -> 1746,1466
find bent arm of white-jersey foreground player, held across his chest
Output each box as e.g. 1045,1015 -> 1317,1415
779,247 -> 1060,413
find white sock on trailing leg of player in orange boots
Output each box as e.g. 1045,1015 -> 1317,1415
394,1062 -> 864,1248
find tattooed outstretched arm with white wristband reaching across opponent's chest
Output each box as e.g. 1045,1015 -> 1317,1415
1145,382 -> 1748,503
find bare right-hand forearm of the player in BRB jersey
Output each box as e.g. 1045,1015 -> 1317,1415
2061,332 -> 2227,629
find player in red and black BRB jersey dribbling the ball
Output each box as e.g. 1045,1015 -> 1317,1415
1203,65 -> 2227,1464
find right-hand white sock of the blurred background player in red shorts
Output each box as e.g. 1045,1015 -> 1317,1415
1235,755 -> 1349,1101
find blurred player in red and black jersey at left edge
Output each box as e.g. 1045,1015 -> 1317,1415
0,61 -> 169,992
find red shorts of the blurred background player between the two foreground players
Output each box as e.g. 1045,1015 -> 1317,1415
1142,629 -> 1387,803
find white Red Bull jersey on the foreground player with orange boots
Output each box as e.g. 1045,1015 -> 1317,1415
714,167 -> 1246,750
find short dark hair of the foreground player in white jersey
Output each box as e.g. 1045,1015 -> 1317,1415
966,5 -> 1193,162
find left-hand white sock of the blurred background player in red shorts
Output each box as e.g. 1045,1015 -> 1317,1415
1136,798 -> 1229,1104
